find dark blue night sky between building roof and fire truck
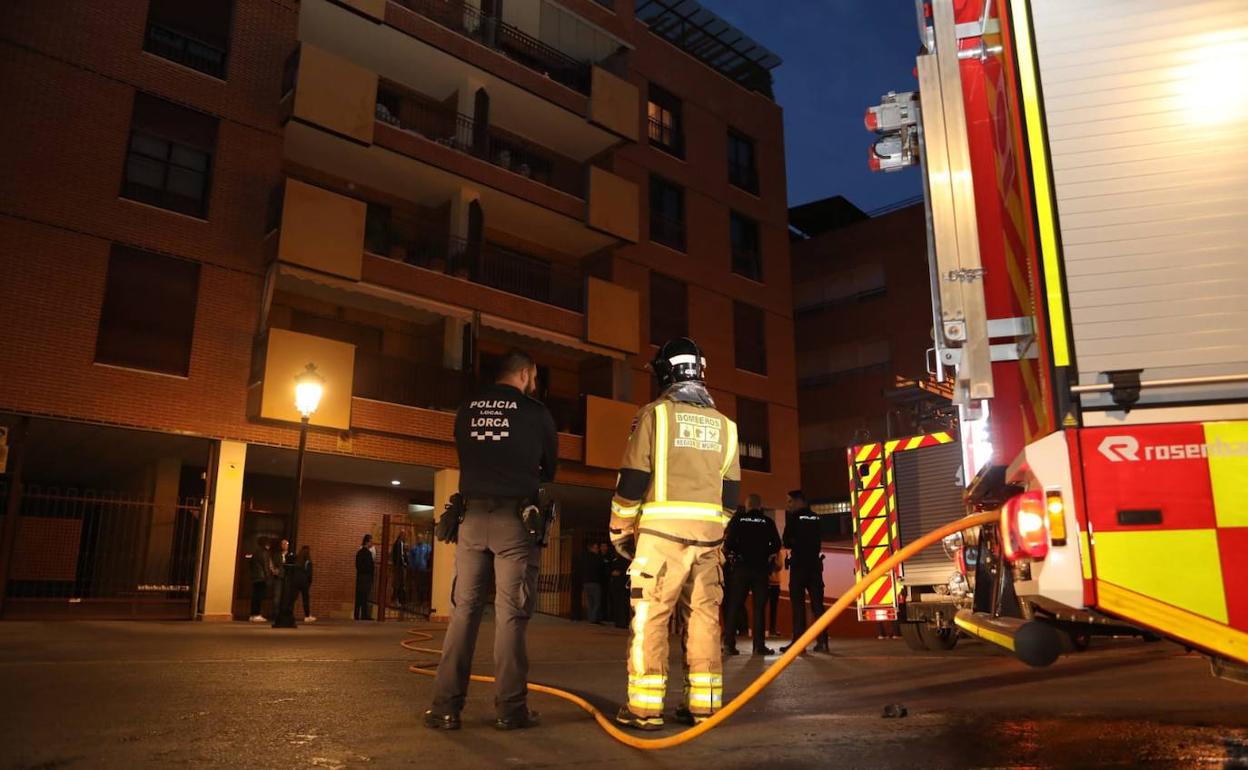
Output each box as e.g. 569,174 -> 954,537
701,0 -> 921,211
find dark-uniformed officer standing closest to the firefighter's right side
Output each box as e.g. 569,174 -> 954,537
724,494 -> 780,655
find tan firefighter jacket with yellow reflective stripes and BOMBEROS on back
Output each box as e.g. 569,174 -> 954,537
610,391 -> 741,545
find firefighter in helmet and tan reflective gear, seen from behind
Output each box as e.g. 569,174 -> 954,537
610,337 -> 741,730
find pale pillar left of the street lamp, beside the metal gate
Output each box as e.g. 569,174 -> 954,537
203,441 -> 247,620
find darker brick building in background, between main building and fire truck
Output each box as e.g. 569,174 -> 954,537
790,196 -> 947,506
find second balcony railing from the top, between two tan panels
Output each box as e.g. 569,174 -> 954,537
377,86 -> 587,198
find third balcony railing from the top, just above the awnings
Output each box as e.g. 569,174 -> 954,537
366,217 -> 584,313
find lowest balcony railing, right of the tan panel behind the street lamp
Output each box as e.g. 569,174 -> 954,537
352,349 -> 474,412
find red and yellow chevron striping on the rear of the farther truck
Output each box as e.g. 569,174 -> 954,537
846,432 -> 953,620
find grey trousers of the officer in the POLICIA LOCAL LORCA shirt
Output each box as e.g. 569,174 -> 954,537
432,500 -> 542,719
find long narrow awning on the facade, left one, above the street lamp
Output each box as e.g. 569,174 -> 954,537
276,265 -> 473,323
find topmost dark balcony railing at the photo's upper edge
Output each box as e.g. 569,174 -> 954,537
398,0 -> 592,95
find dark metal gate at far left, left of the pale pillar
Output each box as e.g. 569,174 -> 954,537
0,484 -> 205,619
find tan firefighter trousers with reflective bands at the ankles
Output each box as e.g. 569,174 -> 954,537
628,533 -> 724,716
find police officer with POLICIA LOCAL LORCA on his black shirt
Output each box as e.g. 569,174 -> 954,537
424,351 -> 559,730
